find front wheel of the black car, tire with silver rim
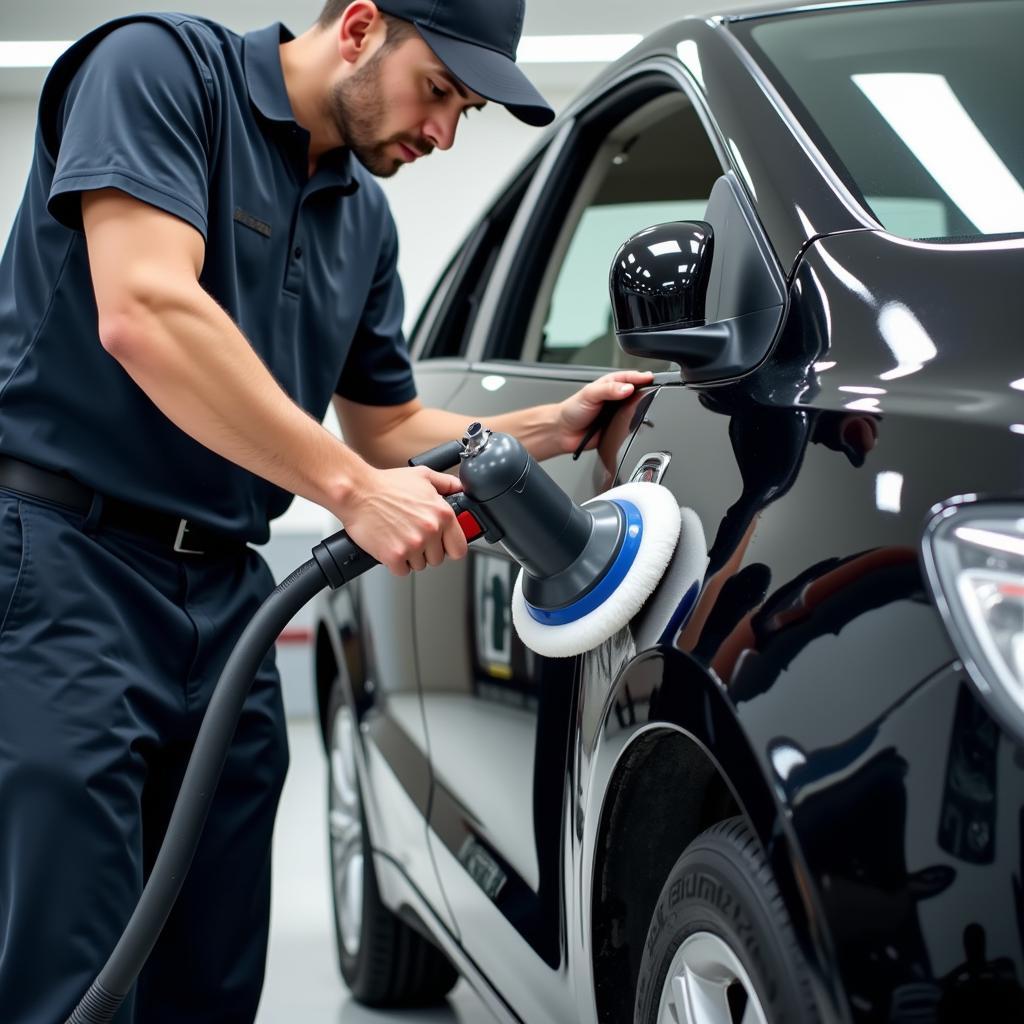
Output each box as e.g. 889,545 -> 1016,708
634,817 -> 819,1024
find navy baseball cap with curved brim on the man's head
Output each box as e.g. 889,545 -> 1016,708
377,0 -> 555,127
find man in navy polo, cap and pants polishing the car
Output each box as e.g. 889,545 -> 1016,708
0,0 -> 650,1024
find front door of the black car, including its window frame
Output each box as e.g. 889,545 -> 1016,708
414,68 -> 723,1020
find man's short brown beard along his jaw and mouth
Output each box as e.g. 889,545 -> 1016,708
328,49 -> 432,178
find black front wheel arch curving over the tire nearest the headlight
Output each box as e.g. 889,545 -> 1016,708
585,649 -> 848,1021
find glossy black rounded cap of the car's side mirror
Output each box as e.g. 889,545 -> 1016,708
608,220 -> 715,334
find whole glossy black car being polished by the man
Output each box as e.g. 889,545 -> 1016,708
315,0 -> 1024,1024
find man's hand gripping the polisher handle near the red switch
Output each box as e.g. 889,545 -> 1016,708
335,466 -> 467,575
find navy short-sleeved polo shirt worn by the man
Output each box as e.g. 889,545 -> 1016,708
0,14 -> 416,543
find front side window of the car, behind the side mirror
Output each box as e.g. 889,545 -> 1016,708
522,93 -> 722,370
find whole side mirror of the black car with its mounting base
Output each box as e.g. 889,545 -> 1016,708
608,172 -> 785,383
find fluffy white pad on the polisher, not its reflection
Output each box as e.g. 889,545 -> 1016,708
512,482 -> 680,657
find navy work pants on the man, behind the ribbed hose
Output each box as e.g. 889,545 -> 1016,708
0,490 -> 288,1024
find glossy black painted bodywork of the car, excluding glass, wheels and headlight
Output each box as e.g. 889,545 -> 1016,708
317,4 -> 1024,1024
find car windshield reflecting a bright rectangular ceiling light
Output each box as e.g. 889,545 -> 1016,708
735,0 -> 1024,241
